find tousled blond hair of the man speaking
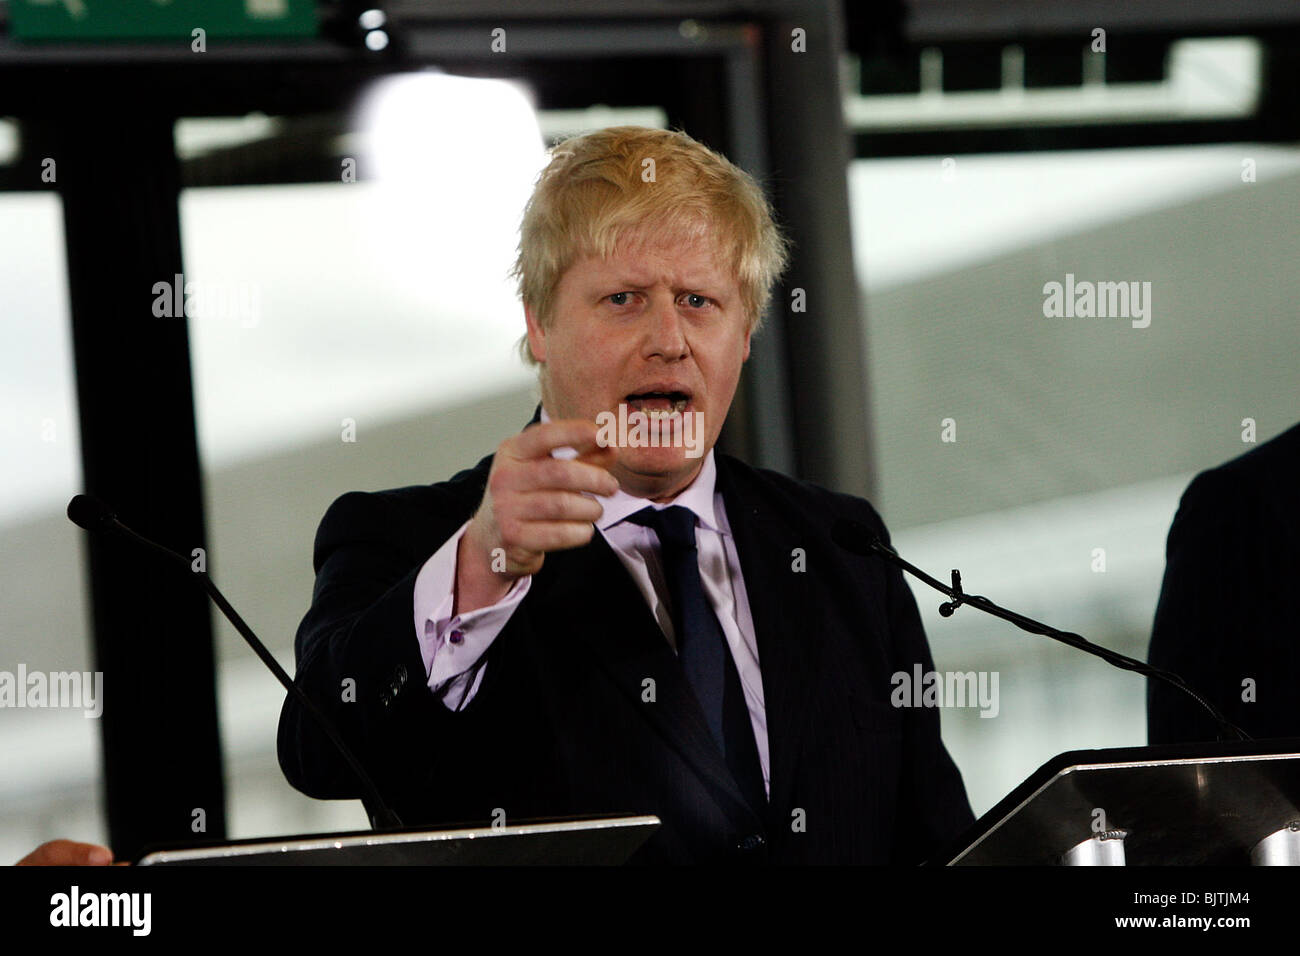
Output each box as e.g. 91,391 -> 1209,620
510,126 -> 789,365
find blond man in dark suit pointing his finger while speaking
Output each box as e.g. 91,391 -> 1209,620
278,126 -> 972,864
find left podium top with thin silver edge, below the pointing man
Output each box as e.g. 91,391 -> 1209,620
135,816 -> 659,866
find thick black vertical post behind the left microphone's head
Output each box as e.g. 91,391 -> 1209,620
53,115 -> 225,858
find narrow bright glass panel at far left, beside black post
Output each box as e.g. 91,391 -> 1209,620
0,183 -> 101,864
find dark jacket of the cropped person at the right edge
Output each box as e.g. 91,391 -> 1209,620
1147,425 -> 1300,744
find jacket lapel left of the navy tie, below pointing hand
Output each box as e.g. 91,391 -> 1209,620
534,532 -> 751,816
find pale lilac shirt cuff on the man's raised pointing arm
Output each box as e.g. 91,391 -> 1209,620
415,522 -> 533,702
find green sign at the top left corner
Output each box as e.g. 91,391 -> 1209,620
9,0 -> 316,40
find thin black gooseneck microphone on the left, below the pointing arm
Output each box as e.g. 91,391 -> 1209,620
68,494 -> 402,830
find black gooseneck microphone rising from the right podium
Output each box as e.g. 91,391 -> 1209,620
831,518 -> 1251,740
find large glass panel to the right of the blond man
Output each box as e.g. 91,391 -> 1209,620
850,143 -> 1300,812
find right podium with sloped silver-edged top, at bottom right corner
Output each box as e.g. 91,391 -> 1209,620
931,737 -> 1300,866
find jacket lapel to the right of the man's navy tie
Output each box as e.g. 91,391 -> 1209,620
715,455 -> 824,808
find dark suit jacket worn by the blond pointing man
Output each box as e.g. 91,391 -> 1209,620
278,421 -> 972,864
